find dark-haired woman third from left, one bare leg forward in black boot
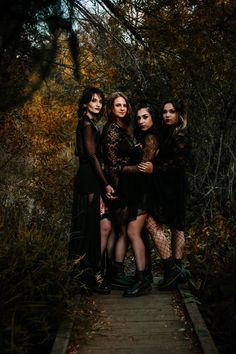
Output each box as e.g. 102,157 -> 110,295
122,102 -> 158,297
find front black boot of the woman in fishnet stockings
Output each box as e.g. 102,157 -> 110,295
157,257 -> 183,290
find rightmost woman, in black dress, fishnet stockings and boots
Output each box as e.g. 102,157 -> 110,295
147,100 -> 190,290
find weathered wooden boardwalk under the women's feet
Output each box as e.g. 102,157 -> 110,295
78,284 -> 203,354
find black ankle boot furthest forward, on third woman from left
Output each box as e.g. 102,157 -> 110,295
123,271 -> 152,297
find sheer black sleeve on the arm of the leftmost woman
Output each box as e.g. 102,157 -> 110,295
83,121 -> 108,186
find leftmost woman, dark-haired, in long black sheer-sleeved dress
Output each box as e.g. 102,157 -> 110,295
69,87 -> 114,293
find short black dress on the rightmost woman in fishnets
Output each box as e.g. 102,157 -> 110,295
151,126 -> 190,230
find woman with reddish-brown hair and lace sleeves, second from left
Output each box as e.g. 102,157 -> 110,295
103,92 -> 158,297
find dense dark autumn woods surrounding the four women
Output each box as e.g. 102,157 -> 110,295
0,0 -> 236,354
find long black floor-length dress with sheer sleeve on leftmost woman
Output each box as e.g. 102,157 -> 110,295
69,116 -> 108,285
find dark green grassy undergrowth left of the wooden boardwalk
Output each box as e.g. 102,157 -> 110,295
0,207 -> 80,354
